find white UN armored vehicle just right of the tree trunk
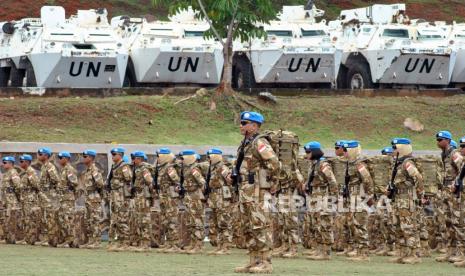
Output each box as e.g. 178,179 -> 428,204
233,5 -> 342,89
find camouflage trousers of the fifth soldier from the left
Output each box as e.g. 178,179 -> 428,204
85,198 -> 102,243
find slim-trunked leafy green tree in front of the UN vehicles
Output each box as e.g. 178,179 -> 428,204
152,0 -> 277,92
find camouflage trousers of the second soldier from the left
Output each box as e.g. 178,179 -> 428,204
21,202 -> 41,244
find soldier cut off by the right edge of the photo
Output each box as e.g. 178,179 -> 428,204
452,137 -> 465,267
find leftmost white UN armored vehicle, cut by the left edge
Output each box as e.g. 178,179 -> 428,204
0,6 -> 128,88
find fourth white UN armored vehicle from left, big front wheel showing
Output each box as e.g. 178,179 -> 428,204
329,4 -> 456,89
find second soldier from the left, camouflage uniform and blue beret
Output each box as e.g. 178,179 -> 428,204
16,154 -> 40,245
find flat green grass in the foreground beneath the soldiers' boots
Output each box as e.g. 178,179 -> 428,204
0,245 -> 465,276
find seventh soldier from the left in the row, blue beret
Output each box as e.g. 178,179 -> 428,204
132,151 -> 153,252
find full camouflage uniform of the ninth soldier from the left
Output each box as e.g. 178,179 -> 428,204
181,163 -> 205,253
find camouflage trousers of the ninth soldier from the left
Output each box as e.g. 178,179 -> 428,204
183,192 -> 205,242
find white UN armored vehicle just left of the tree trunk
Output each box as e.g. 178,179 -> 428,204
112,8 -> 224,86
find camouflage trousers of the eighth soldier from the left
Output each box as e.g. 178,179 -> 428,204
160,195 -> 180,246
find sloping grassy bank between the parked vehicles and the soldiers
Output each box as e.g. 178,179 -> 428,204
0,93 -> 465,150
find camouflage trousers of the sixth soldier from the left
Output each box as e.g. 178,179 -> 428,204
109,188 -> 133,245
